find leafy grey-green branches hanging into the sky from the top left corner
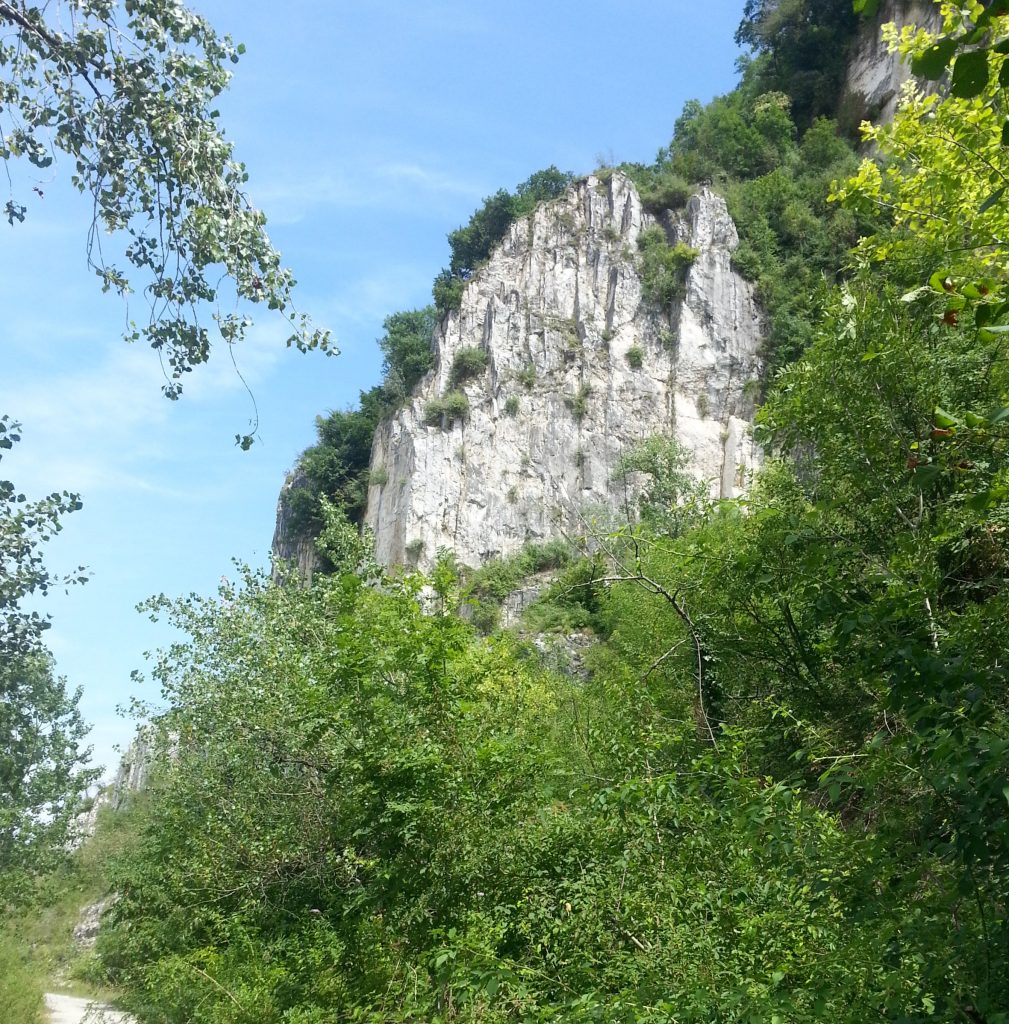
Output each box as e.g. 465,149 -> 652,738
0,0 -> 329,436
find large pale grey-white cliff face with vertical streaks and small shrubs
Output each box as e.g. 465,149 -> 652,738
366,173 -> 761,565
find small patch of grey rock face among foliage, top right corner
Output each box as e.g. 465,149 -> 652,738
841,0 -> 942,128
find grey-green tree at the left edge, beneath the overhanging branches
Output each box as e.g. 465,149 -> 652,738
0,417 -> 97,907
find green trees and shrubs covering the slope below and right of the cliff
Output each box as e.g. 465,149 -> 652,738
92,2 -> 1009,1024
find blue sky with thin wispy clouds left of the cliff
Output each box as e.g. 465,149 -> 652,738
0,0 -> 743,764
